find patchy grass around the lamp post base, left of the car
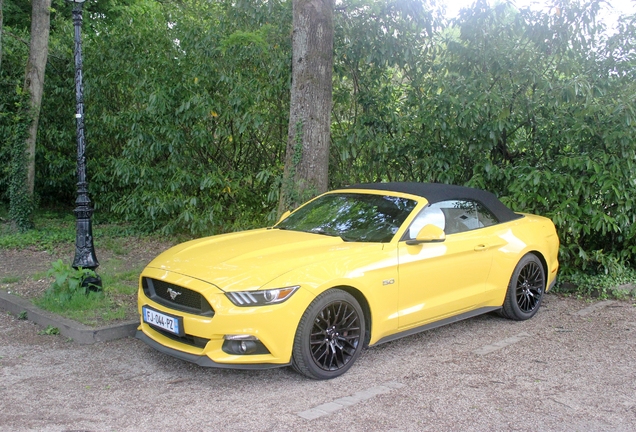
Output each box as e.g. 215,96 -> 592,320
0,204 -> 176,326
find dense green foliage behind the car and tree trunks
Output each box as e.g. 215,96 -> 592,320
0,0 -> 636,286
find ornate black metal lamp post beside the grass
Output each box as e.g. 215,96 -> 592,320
67,0 -> 102,290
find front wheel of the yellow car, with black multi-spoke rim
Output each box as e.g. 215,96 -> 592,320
292,289 -> 365,380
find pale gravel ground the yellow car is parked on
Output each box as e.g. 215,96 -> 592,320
0,295 -> 636,432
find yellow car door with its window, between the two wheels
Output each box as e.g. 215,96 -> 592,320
398,200 -> 497,329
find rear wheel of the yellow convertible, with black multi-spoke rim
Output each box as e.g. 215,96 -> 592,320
499,253 -> 545,321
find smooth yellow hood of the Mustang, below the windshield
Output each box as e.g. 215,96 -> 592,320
148,229 -> 382,292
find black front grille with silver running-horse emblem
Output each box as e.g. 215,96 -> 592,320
141,277 -> 214,317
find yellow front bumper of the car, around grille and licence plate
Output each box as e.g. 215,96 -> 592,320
136,268 -> 313,369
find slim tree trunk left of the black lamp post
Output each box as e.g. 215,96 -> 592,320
24,0 -> 51,195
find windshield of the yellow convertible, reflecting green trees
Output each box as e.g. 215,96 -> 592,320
275,193 -> 417,243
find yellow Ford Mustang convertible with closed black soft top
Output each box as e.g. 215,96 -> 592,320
137,183 -> 559,379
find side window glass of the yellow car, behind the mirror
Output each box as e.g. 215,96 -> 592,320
407,200 -> 498,239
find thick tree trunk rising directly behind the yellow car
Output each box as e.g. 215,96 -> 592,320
279,0 -> 334,214
